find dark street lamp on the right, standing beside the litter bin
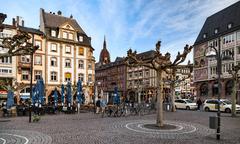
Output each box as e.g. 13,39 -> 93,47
204,38 -> 232,140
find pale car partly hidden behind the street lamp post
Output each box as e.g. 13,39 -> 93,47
203,99 -> 240,113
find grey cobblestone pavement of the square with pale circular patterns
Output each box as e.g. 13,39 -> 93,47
0,110 -> 240,144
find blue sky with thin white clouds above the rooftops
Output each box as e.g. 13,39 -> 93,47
0,0 -> 239,62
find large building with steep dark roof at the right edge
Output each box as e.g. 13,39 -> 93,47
194,2 -> 240,102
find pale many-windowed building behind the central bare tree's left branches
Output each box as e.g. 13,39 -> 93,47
127,50 -> 158,102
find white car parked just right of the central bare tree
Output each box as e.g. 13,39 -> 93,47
175,99 -> 197,110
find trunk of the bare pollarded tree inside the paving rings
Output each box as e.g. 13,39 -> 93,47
157,70 -> 163,127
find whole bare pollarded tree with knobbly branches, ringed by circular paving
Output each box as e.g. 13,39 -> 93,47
125,41 -> 193,127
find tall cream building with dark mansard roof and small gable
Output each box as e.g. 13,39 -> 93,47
40,9 -> 95,103
